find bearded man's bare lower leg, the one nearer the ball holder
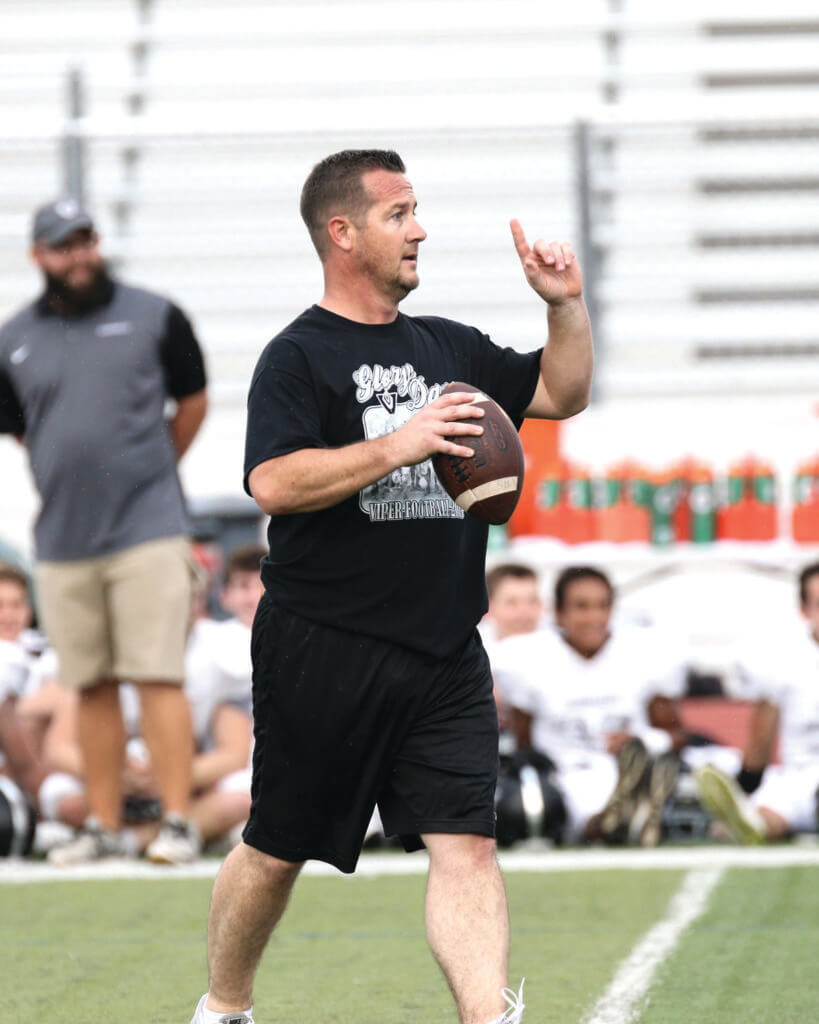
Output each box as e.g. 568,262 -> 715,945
139,683 -> 193,817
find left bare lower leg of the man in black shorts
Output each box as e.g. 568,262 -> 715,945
207,843 -> 302,1013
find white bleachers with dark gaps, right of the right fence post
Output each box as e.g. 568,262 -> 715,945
598,0 -> 819,394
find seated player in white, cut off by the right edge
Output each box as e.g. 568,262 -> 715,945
696,562 -> 819,843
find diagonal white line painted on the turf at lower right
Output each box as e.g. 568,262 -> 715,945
584,867 -> 725,1024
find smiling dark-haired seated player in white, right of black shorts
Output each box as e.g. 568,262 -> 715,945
493,566 -> 688,846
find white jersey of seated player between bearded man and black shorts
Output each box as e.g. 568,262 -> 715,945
185,618 -> 253,750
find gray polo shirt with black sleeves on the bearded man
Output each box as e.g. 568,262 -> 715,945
0,283 -> 205,561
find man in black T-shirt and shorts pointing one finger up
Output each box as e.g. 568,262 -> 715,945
193,151 -> 592,1024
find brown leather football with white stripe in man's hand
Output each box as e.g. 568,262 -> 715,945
432,381 -> 523,523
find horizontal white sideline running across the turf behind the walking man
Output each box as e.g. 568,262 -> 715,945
0,846 -> 819,886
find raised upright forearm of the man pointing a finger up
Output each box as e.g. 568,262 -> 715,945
541,296 -> 594,417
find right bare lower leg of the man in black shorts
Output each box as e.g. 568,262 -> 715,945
424,835 -> 509,1024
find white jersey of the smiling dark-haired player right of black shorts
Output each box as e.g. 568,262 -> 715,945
492,629 -> 685,770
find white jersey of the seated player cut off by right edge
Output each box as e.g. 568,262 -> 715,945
740,629 -> 819,768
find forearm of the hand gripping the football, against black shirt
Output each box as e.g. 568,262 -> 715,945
249,436 -> 399,515
